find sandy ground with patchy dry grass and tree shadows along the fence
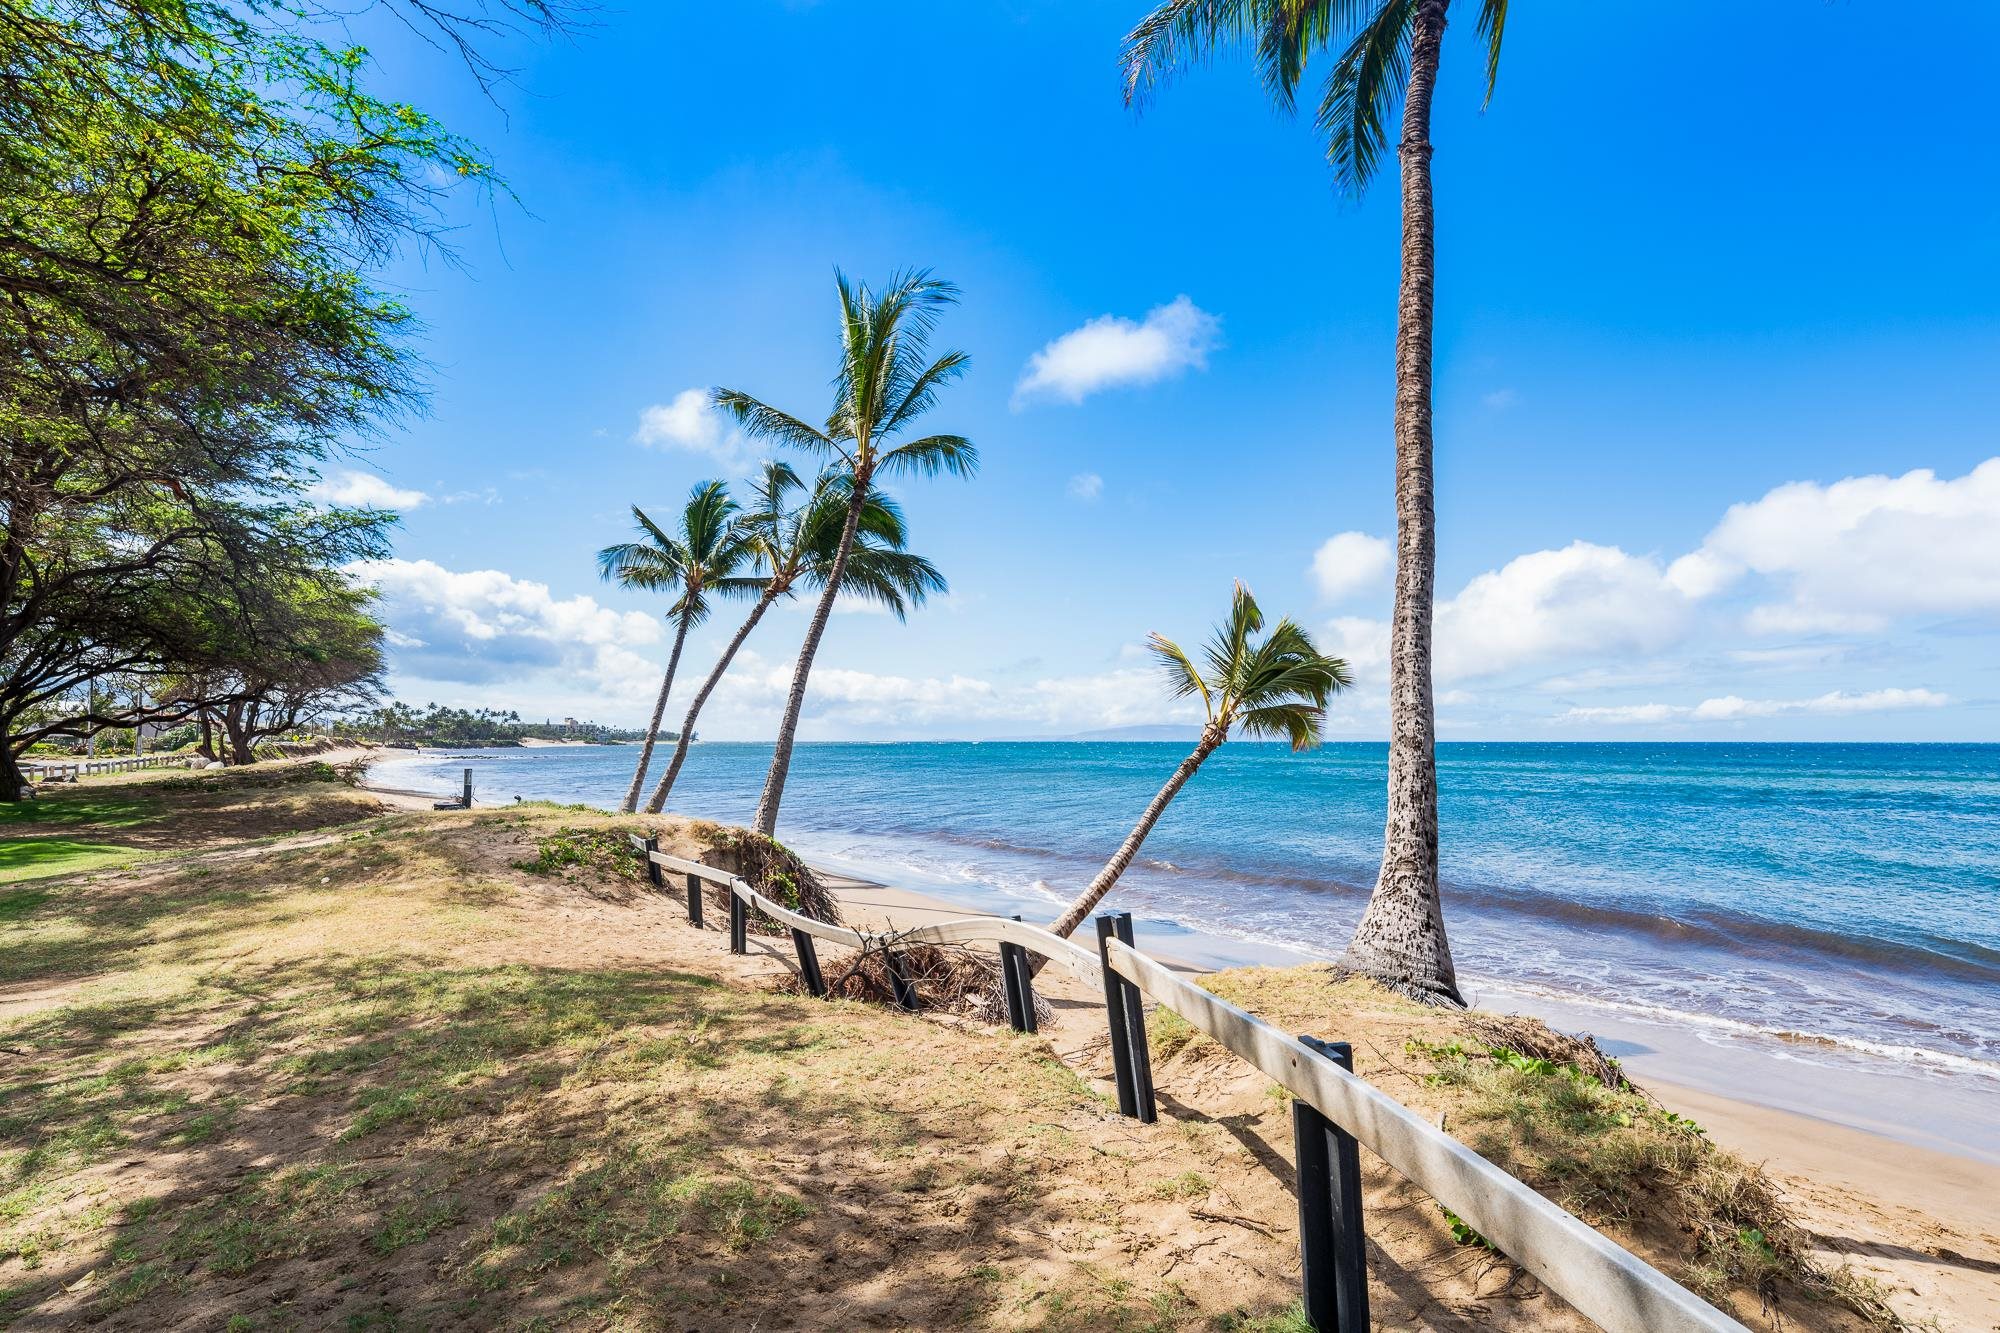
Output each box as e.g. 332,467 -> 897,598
0,764 -> 1968,1331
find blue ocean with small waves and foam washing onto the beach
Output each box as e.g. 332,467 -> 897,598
374,743 -> 2000,1161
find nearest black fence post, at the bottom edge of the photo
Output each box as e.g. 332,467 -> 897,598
1292,1037 -> 1368,1333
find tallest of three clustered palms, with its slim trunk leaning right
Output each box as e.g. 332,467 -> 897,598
714,270 -> 978,837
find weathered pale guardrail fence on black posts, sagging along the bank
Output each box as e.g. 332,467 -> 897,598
632,835 -> 1748,1333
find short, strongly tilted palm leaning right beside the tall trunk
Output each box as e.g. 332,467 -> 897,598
1048,582 -> 1348,937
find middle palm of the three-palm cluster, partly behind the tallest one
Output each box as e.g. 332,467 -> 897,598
646,462 -> 944,815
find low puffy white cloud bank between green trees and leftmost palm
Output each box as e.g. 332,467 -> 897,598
348,560 -> 664,701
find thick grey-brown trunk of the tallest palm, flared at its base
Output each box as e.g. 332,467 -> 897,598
1340,0 -> 1464,1005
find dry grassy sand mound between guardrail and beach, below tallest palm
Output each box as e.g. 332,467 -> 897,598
1148,967 -> 1896,1327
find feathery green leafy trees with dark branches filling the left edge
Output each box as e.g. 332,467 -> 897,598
0,0 -> 556,801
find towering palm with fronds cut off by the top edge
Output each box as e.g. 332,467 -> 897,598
1124,0 -> 1506,1005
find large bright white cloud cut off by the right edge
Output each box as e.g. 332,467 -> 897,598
1676,458 -> 2000,632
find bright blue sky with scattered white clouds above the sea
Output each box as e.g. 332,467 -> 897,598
330,0 -> 2000,741
